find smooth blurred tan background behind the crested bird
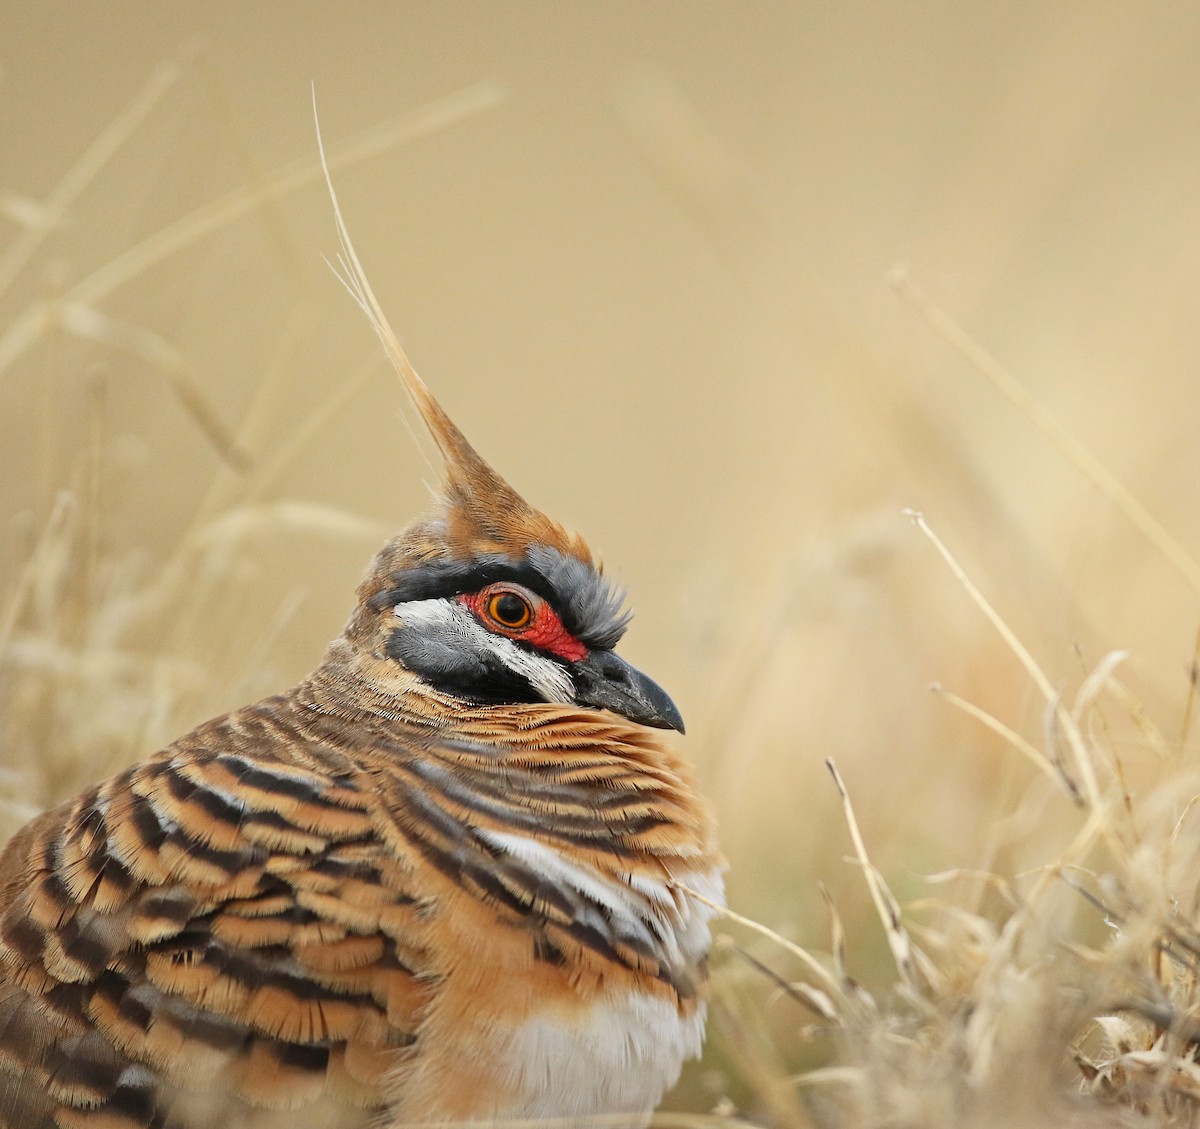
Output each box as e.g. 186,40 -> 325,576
0,0 -> 1200,1103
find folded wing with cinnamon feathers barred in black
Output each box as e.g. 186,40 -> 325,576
0,698 -> 431,1129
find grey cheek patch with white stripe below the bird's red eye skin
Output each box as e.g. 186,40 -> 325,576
390,599 -> 575,704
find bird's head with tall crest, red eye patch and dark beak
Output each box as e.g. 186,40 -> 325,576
330,185 -> 683,733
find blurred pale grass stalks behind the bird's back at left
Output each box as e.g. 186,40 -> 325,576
0,68 -> 503,839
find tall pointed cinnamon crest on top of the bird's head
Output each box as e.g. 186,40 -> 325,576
313,98 -> 592,563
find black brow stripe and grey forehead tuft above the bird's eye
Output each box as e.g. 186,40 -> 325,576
371,546 -> 630,649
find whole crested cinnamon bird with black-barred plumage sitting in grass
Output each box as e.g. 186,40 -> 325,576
0,207 -> 721,1129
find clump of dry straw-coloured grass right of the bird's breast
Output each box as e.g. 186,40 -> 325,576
700,515 -> 1200,1129
